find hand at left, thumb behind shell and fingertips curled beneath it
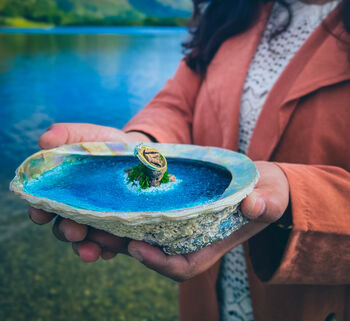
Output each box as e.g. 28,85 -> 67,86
29,123 -> 151,262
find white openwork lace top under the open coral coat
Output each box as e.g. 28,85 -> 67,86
219,0 -> 339,321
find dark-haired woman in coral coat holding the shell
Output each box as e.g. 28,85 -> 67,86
30,0 -> 350,321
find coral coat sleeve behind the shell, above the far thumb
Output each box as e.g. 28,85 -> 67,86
123,60 -> 201,144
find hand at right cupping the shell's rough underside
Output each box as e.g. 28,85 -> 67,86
128,162 -> 289,281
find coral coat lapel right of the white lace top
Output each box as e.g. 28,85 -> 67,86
248,9 -> 350,160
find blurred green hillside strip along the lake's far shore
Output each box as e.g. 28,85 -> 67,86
0,0 -> 191,27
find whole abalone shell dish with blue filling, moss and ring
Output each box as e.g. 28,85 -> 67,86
10,142 -> 259,255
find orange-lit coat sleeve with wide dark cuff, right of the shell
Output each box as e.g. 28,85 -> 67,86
249,163 -> 350,284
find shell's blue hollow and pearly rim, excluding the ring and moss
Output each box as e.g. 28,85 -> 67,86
10,142 -> 259,220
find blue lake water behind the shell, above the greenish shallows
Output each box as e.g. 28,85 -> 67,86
0,27 -> 186,175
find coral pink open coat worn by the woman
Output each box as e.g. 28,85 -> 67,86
125,7 -> 350,321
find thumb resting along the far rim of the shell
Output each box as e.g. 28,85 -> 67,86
39,123 -> 125,149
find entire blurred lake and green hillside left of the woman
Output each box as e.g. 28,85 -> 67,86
0,0 -> 191,321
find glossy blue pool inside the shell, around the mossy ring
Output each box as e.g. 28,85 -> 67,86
24,156 -> 231,212
